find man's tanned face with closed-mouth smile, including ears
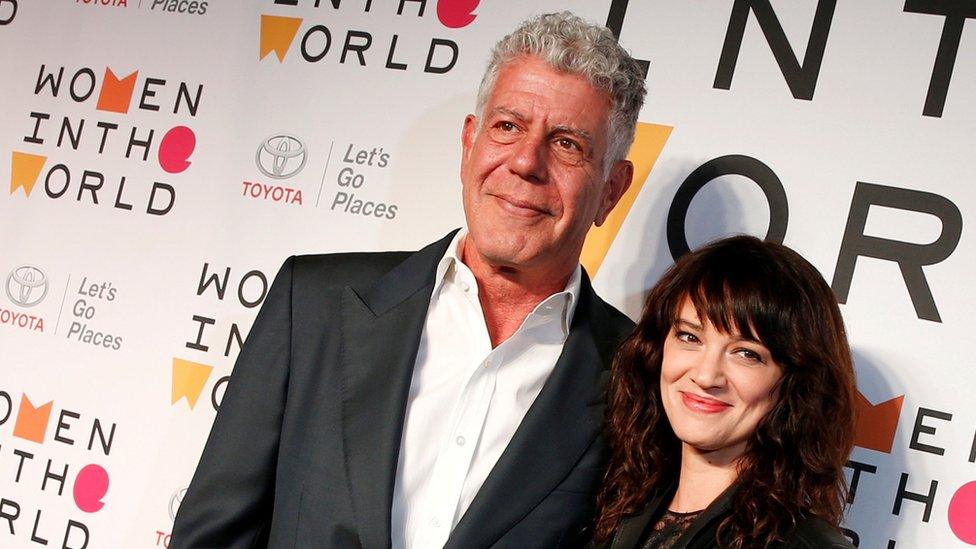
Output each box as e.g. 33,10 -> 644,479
461,56 -> 633,274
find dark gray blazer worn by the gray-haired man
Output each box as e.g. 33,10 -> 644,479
170,233 -> 633,549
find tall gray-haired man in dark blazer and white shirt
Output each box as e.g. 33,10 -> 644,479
170,9 -> 644,549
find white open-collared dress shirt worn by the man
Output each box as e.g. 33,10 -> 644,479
390,231 -> 582,549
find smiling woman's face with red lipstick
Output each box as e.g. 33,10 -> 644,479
661,299 -> 783,463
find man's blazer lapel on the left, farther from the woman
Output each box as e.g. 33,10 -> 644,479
340,233 -> 454,547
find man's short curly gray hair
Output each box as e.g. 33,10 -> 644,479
476,11 -> 647,174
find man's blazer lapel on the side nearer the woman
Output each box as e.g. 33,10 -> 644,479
445,275 -> 613,549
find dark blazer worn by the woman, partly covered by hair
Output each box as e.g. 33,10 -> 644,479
603,484 -> 854,549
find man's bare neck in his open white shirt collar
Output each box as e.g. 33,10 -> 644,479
461,242 -> 576,348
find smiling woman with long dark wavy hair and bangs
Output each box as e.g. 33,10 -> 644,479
594,236 -> 855,549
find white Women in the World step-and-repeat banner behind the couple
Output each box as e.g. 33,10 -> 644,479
0,0 -> 976,549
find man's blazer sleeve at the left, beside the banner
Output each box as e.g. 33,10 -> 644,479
170,257 -> 295,549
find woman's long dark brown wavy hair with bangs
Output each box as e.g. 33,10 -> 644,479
594,236 -> 855,548
